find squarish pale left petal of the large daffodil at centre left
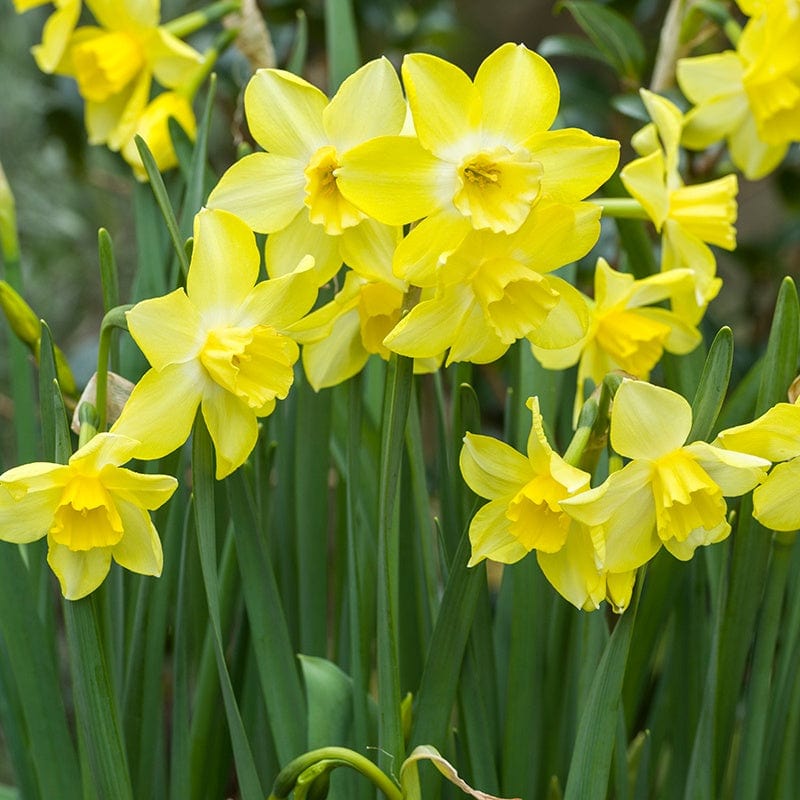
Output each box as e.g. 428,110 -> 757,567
125,289 -> 204,370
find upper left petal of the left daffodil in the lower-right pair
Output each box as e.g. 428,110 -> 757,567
458,433 -> 533,500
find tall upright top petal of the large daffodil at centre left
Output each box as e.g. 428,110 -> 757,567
186,208 -> 261,318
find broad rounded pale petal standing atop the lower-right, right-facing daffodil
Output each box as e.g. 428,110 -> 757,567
611,380 -> 692,460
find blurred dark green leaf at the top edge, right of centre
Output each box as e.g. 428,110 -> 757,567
558,0 -> 647,82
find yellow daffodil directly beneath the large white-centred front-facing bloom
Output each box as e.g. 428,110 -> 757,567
384,203 -> 600,364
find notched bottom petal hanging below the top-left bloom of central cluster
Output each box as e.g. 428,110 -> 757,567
264,209 -> 342,286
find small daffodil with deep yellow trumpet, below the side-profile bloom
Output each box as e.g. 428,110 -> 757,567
533,258 -> 702,419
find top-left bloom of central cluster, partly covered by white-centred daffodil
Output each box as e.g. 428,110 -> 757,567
208,58 -> 406,284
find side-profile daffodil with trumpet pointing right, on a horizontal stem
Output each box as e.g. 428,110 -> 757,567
620,89 -> 738,323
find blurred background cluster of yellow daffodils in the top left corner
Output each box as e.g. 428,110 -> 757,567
14,0 -> 225,180
